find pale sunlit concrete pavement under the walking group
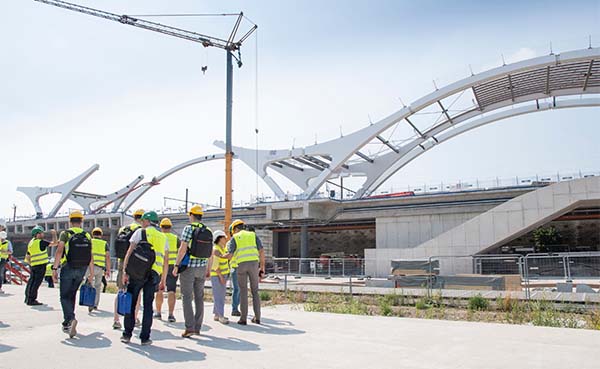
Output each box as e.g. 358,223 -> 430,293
0,285 -> 600,369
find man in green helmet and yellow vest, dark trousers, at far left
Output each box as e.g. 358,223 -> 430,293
25,226 -> 57,306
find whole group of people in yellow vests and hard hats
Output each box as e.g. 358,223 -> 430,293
10,205 -> 265,345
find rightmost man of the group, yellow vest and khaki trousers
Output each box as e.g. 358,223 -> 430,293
228,219 -> 265,325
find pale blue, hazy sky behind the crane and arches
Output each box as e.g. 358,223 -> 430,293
0,0 -> 600,218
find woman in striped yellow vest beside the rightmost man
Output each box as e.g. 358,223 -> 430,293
208,231 -> 229,324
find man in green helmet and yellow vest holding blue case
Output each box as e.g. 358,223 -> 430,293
121,211 -> 169,346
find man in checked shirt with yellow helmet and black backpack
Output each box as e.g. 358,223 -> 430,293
173,205 -> 213,338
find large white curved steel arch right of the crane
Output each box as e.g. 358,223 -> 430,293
227,48 -> 600,199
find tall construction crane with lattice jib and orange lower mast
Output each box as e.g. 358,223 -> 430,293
34,0 -> 258,234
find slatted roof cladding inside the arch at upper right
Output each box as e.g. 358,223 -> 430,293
473,60 -> 600,109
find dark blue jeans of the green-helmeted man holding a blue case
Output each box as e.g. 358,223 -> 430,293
123,271 -> 160,341
